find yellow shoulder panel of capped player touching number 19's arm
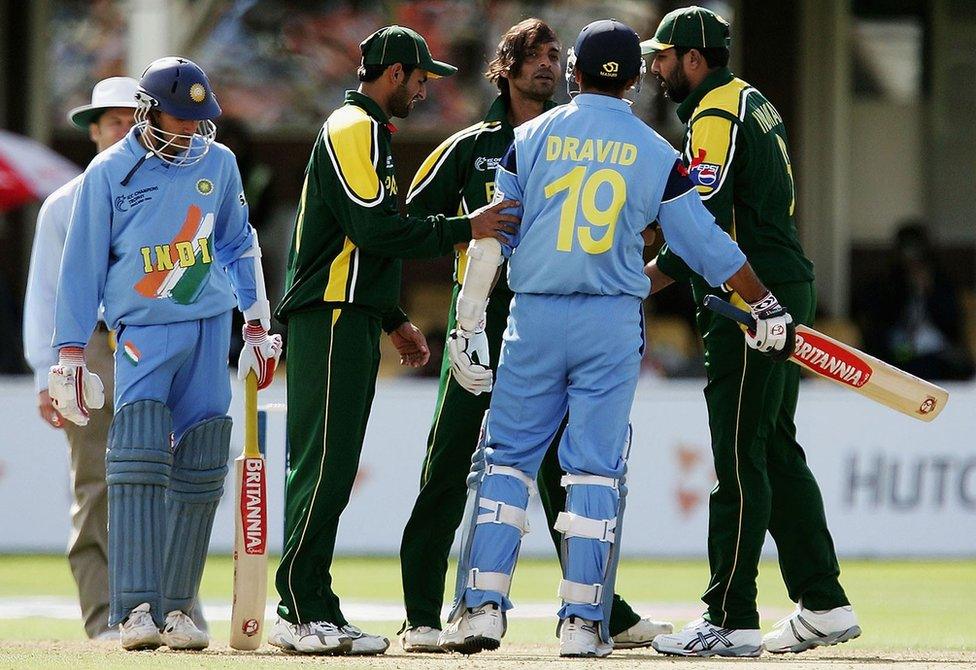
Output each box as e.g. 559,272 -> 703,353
323,105 -> 384,207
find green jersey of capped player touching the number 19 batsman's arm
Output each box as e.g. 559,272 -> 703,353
275,91 -> 471,331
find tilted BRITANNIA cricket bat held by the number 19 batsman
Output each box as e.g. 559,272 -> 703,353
705,295 -> 949,421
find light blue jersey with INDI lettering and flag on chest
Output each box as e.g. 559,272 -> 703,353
53,128 -> 263,347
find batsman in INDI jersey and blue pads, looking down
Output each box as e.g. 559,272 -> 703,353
49,57 -> 281,649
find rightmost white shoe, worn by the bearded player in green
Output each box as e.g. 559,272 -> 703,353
763,604 -> 861,654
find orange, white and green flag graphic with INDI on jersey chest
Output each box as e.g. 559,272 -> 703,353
135,205 -> 214,305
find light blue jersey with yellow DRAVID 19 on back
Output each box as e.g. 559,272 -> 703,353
495,93 -> 746,298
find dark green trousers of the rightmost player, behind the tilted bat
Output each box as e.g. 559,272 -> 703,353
702,282 -> 849,628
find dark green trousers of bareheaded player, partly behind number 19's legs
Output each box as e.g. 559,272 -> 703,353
400,284 -> 640,635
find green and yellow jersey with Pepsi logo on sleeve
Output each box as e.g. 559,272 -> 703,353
658,68 -> 813,308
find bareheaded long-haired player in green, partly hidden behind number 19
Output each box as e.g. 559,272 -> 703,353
400,18 -> 672,652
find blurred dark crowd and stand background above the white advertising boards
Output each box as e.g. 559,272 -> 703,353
0,0 -> 976,380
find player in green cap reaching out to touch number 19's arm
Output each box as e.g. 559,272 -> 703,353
269,26 -> 518,654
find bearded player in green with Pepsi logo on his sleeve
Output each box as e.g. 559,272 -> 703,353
641,6 -> 861,656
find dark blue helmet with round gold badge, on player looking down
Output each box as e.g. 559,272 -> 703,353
139,56 -> 220,121
